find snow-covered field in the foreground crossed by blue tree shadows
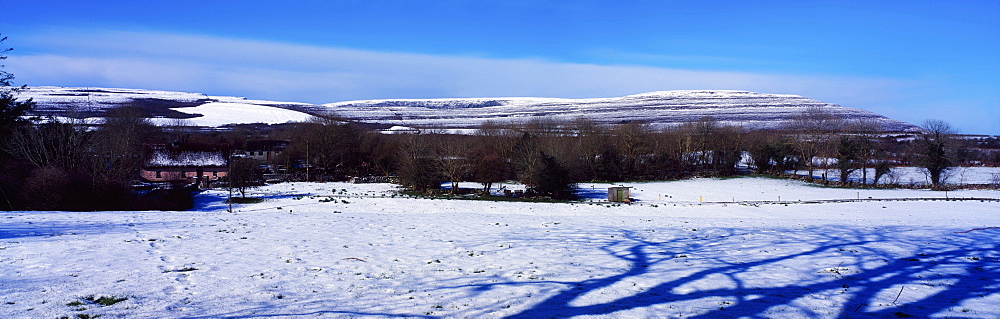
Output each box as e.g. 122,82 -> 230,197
0,178 -> 1000,318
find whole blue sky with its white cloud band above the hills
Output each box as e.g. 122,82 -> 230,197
0,0 -> 1000,134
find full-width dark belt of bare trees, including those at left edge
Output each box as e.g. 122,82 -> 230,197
0,35 -> 1000,210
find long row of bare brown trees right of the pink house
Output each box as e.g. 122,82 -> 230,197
266,108 -> 1000,198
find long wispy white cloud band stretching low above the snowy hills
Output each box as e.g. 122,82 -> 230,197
8,31 -> 902,104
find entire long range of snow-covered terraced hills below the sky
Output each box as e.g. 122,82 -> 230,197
20,87 -> 919,132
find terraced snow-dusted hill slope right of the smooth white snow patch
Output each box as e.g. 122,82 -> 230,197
326,90 -> 917,131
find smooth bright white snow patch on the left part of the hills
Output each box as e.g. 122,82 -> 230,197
164,102 -> 311,127
